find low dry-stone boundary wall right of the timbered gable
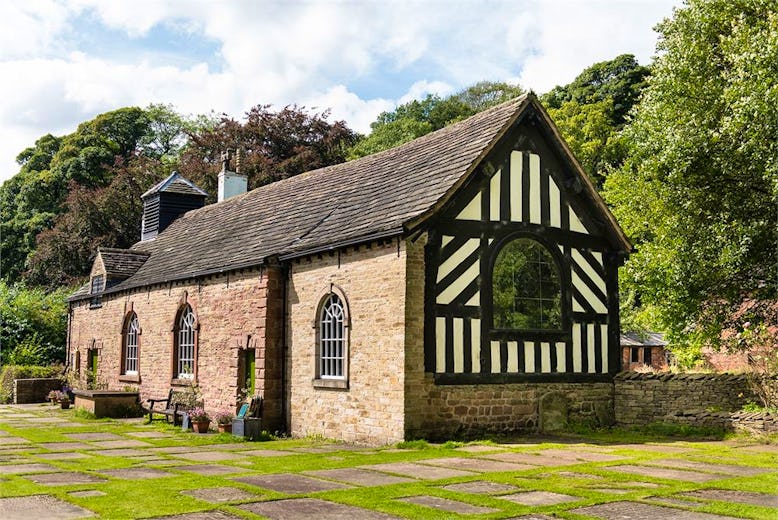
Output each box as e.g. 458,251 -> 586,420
614,372 -> 753,425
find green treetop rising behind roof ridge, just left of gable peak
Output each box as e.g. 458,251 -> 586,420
348,81 -> 524,159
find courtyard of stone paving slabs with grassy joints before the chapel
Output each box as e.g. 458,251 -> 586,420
0,405 -> 778,520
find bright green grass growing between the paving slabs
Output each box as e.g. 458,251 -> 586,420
0,404 -> 778,519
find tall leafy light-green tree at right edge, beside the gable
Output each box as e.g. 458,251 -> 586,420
605,0 -> 778,359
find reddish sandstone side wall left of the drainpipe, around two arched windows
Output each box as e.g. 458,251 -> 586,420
69,268 -> 283,427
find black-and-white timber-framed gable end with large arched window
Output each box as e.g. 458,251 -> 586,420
420,96 -> 631,384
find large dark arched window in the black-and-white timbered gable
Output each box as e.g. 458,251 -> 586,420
492,238 -> 562,330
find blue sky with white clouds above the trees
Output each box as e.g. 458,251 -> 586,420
0,0 -> 681,181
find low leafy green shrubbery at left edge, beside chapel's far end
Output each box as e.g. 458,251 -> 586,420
0,280 -> 69,365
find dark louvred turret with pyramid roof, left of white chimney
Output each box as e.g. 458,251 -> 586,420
141,172 -> 208,241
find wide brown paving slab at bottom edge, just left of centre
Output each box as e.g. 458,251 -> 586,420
237,498 -> 399,520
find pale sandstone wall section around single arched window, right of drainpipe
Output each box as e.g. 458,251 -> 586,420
286,240 -> 406,444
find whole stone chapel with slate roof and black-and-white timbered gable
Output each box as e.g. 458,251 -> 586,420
68,94 -> 631,444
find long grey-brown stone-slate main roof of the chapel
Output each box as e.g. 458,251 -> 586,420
71,94 -> 629,298
